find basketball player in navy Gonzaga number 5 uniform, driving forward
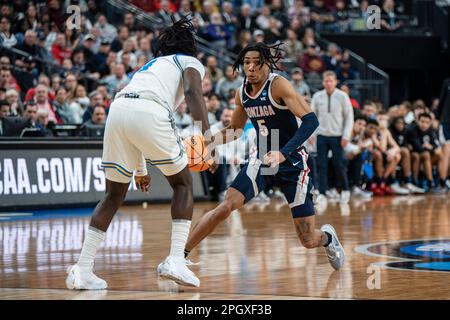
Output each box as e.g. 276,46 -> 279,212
185,43 -> 345,270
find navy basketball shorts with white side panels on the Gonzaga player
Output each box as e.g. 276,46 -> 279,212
230,150 -> 314,218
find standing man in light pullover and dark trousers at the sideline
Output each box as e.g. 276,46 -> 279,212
311,71 -> 353,203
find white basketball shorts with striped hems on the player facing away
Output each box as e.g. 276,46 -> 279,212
102,98 -> 188,183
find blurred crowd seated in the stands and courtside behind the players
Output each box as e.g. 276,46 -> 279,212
0,0 -> 450,201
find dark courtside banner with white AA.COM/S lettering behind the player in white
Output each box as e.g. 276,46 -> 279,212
0,141 -> 206,208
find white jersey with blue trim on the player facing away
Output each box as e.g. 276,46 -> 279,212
118,54 -> 205,111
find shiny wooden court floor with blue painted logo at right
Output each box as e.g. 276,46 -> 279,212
0,195 -> 450,299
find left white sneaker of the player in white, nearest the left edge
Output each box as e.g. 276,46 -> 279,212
66,264 -> 108,290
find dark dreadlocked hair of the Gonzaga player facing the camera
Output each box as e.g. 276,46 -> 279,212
233,42 -> 283,91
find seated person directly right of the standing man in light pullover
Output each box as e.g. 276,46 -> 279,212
344,116 -> 373,199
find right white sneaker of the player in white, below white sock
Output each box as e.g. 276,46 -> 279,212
157,256 -> 200,287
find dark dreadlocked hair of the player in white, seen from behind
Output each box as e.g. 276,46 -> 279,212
155,15 -> 197,57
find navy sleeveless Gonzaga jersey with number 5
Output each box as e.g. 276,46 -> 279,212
240,73 -> 299,158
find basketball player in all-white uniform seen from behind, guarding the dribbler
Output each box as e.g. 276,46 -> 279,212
66,18 -> 213,290
